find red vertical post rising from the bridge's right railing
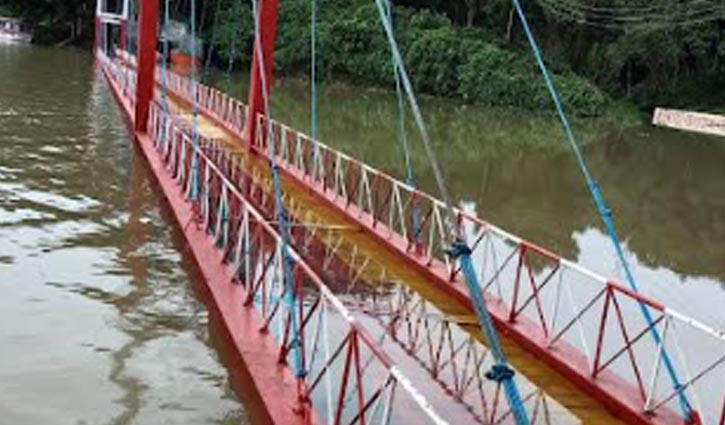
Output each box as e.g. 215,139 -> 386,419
244,0 -> 279,146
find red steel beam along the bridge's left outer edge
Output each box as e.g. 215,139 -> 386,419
97,55 -> 310,425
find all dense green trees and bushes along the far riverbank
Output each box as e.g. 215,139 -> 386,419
0,0 -> 725,115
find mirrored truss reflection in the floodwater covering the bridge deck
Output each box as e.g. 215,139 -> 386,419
192,137 -> 578,424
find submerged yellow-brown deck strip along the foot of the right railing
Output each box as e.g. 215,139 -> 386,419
167,88 -> 622,424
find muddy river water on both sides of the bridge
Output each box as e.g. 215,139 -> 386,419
0,46 -> 725,425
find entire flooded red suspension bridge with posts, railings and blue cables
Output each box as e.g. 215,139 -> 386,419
94,0 -> 725,425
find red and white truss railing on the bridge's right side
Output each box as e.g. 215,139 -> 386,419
109,52 -> 725,425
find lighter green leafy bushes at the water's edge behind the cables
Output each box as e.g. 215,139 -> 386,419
206,0 -> 607,116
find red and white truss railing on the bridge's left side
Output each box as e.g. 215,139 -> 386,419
141,97 -> 446,424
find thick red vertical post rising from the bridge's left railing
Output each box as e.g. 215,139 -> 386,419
135,0 -> 159,133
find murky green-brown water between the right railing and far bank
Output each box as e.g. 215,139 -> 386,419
212,71 -> 725,328
